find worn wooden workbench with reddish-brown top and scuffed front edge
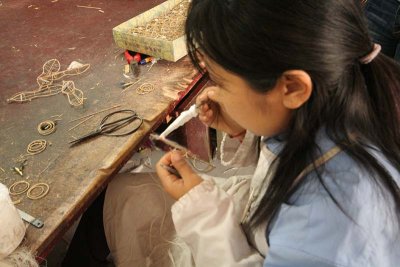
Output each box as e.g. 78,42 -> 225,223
0,0 -> 199,256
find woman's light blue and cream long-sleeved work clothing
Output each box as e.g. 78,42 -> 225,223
172,132 -> 400,267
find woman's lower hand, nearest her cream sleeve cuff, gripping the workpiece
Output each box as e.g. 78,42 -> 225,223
156,150 -> 203,200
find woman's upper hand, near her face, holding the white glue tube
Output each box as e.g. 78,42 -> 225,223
196,86 -> 245,136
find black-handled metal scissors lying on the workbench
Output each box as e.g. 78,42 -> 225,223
69,109 -> 143,146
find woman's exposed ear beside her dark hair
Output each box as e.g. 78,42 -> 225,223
281,70 -> 313,109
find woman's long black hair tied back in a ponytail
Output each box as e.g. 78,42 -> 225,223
186,0 -> 400,226
